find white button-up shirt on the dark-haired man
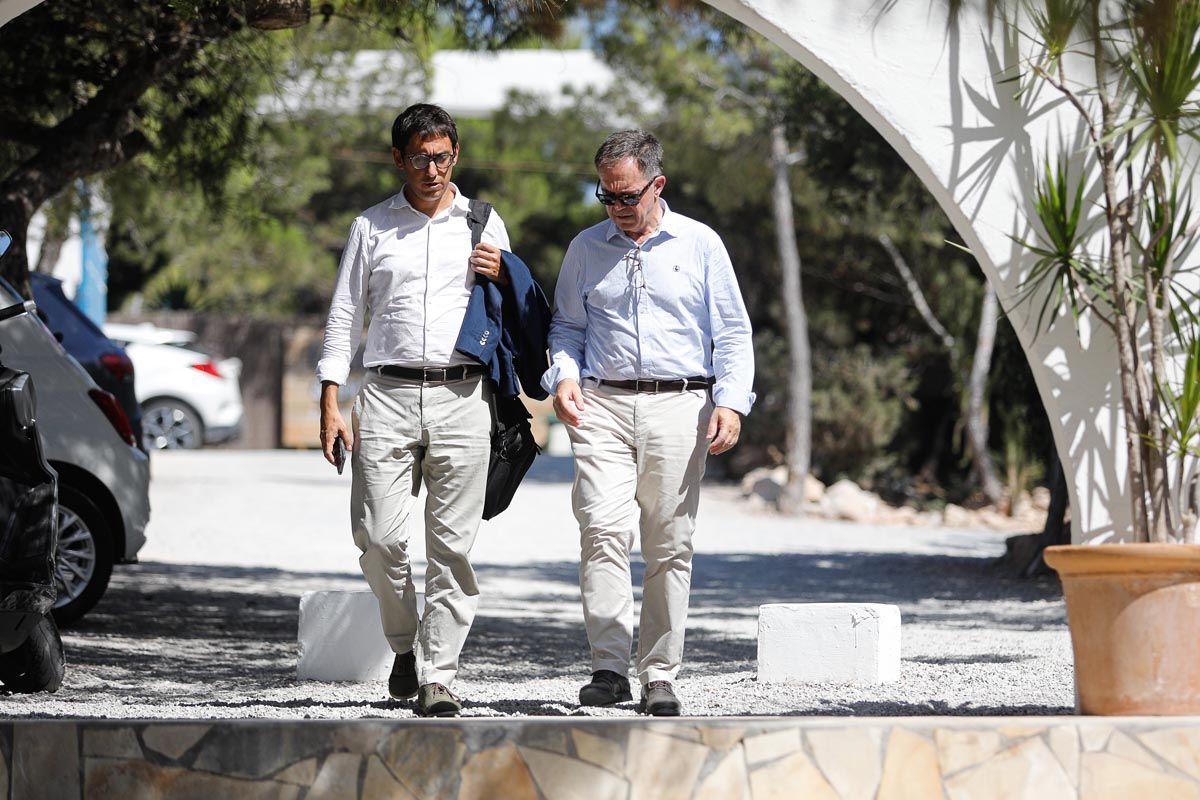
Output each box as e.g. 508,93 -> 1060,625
317,184 -> 511,385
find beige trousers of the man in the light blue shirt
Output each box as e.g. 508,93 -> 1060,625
568,379 -> 713,684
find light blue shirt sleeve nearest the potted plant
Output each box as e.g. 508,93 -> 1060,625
706,234 -> 755,414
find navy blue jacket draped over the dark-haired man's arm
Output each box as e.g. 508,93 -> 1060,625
455,251 -> 550,399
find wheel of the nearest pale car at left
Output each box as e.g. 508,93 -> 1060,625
54,486 -> 114,625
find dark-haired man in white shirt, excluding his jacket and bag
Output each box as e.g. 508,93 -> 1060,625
317,103 -> 509,716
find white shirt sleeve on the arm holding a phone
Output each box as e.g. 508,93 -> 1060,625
317,217 -> 371,386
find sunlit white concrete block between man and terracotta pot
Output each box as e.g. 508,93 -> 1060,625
758,603 -> 900,684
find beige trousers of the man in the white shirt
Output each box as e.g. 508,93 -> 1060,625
350,373 -> 492,686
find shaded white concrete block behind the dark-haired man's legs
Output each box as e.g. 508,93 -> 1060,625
296,591 -> 425,681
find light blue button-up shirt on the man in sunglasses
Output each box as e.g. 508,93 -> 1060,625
541,199 -> 755,414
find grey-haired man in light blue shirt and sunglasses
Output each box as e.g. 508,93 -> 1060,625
542,131 -> 755,716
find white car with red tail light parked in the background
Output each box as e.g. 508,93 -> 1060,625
104,323 -> 242,451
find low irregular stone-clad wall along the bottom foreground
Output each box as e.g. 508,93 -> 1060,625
9,717 -> 1200,800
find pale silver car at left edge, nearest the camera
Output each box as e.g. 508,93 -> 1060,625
0,281 -> 150,624
